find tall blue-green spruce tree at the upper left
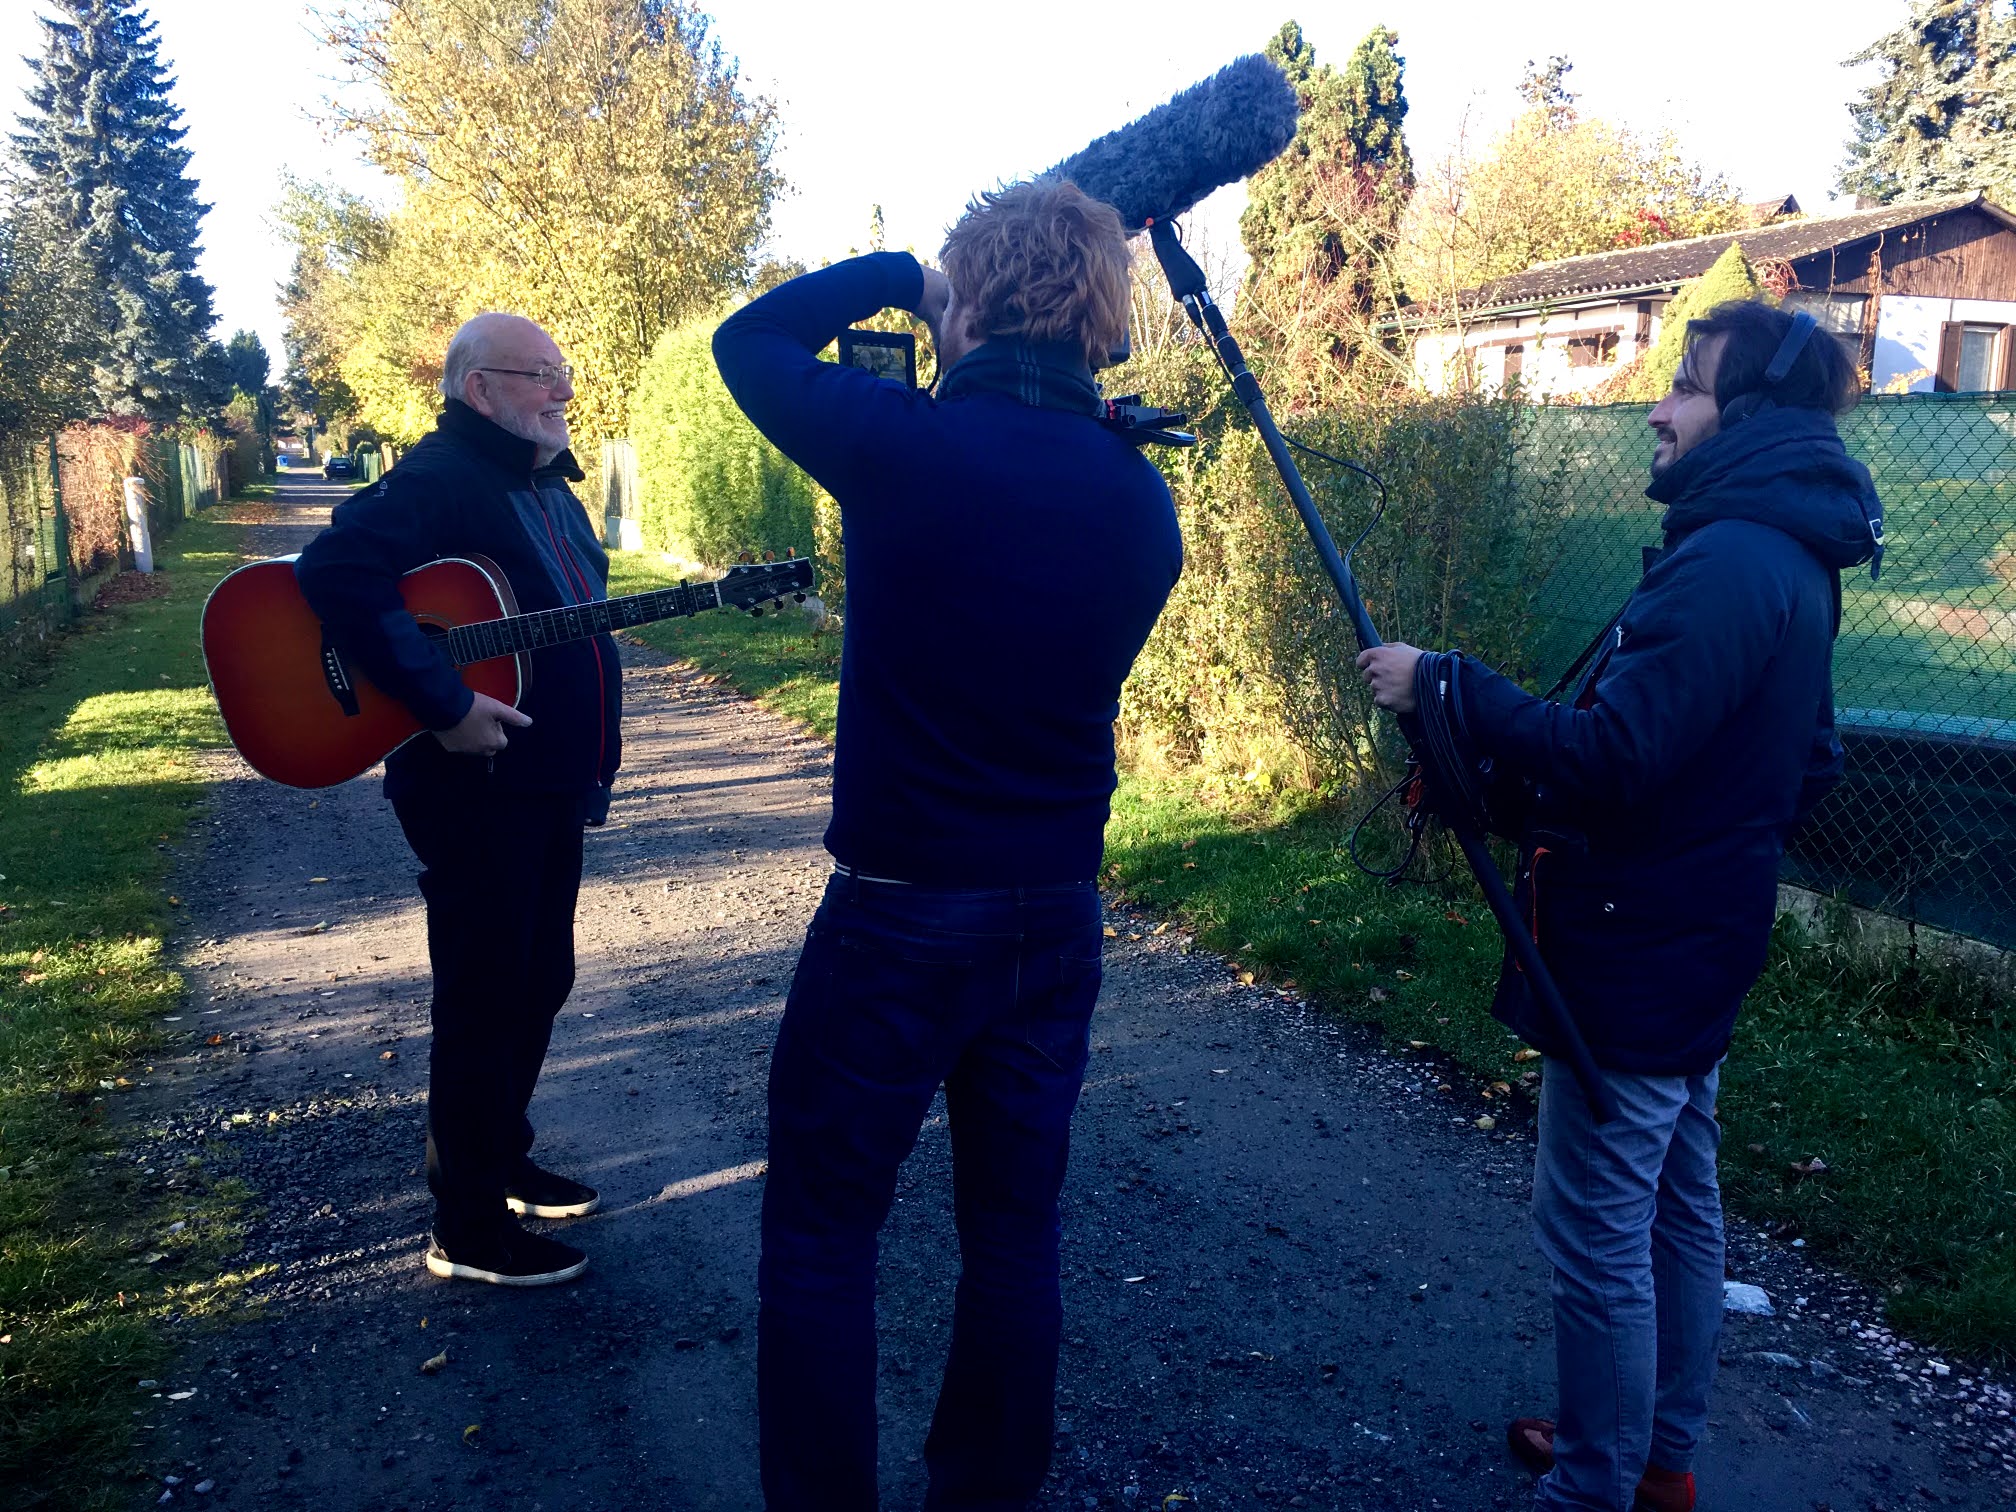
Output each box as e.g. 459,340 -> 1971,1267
14,0 -> 222,419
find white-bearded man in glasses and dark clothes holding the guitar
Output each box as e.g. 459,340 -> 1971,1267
294,314 -> 623,1286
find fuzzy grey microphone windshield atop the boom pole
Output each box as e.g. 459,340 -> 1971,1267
1042,52 -> 1300,236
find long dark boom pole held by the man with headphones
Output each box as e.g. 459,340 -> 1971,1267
1149,220 -> 1617,1123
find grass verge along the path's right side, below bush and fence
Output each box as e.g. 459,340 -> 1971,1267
619,552 -> 2016,1361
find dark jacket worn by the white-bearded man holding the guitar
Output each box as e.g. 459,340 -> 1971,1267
294,399 -> 623,798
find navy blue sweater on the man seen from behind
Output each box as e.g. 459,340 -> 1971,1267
714,252 -> 1183,887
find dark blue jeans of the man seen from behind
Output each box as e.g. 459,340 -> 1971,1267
756,875 -> 1103,1512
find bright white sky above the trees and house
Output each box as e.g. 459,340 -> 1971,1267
0,0 -> 1905,369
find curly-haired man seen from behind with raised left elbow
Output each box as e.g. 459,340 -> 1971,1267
714,181 -> 1181,1512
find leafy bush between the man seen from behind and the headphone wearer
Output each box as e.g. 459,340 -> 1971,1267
1121,375 -> 1554,790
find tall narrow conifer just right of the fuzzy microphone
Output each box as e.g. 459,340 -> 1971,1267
1240,20 -> 1413,393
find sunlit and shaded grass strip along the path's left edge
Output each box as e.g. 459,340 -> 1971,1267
0,520 -> 264,1508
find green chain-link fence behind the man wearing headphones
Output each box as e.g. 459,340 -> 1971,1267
1516,393 -> 2016,946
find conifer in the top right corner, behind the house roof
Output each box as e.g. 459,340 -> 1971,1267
1839,0 -> 2016,204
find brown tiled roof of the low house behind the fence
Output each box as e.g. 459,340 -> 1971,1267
1458,194 -> 2016,310
